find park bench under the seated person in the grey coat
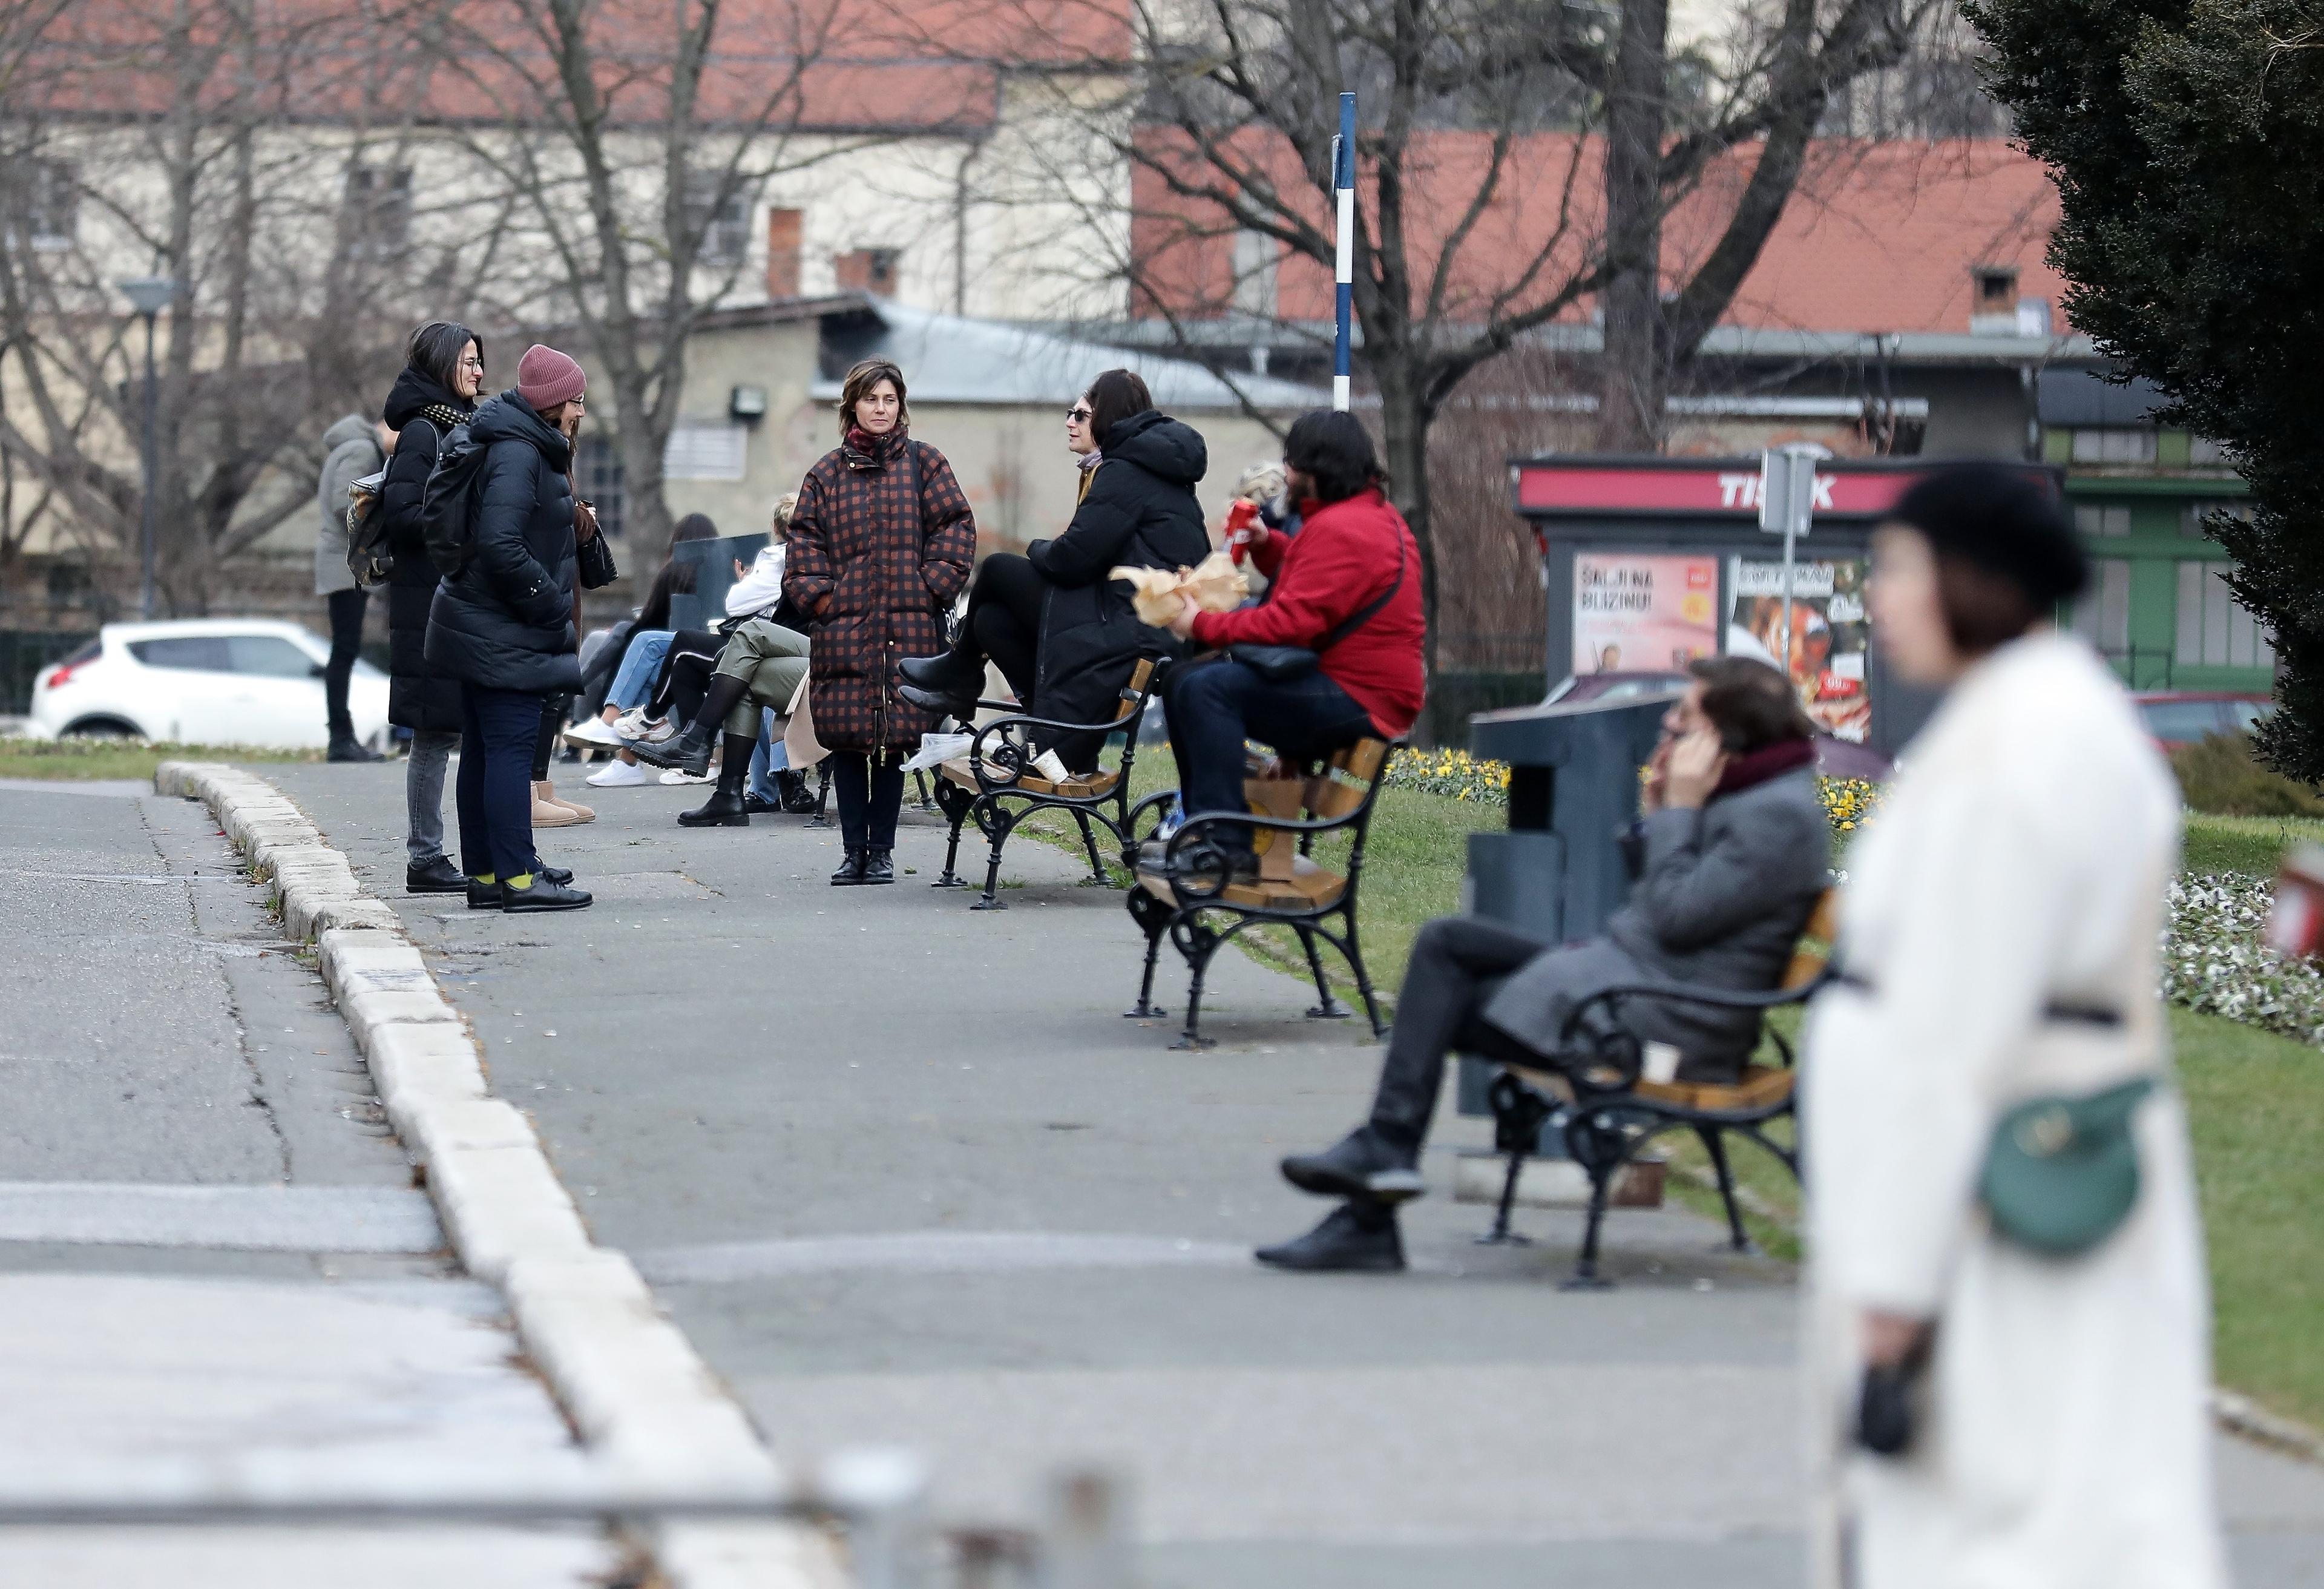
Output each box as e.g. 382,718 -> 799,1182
1480,890 -> 1838,1289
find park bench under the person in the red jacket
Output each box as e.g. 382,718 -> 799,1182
1129,739 -> 1399,1048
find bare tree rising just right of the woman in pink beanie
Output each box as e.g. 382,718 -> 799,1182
439,0 -> 881,558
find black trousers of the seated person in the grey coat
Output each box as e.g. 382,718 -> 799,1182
1371,915 -> 1552,1148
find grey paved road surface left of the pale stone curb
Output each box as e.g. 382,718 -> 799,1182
0,783 -> 616,1589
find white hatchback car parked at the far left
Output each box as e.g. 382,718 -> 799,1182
30,618 -> 388,751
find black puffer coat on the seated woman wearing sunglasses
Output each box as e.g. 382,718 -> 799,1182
1025,409 -> 1211,766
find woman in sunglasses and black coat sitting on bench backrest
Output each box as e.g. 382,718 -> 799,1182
902,369 -> 1211,771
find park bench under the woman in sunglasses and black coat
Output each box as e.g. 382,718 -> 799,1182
937,657 -> 1162,910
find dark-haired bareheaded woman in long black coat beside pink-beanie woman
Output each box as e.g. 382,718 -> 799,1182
376,321 -> 484,895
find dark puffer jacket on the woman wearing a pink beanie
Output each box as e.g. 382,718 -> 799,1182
428,390 -> 609,694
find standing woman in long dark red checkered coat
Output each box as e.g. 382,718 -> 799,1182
783,358 -> 976,885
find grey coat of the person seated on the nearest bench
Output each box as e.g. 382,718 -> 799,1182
1483,766 -> 1831,1081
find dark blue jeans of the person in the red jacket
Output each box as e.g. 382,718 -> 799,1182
1162,657 -> 1378,850
